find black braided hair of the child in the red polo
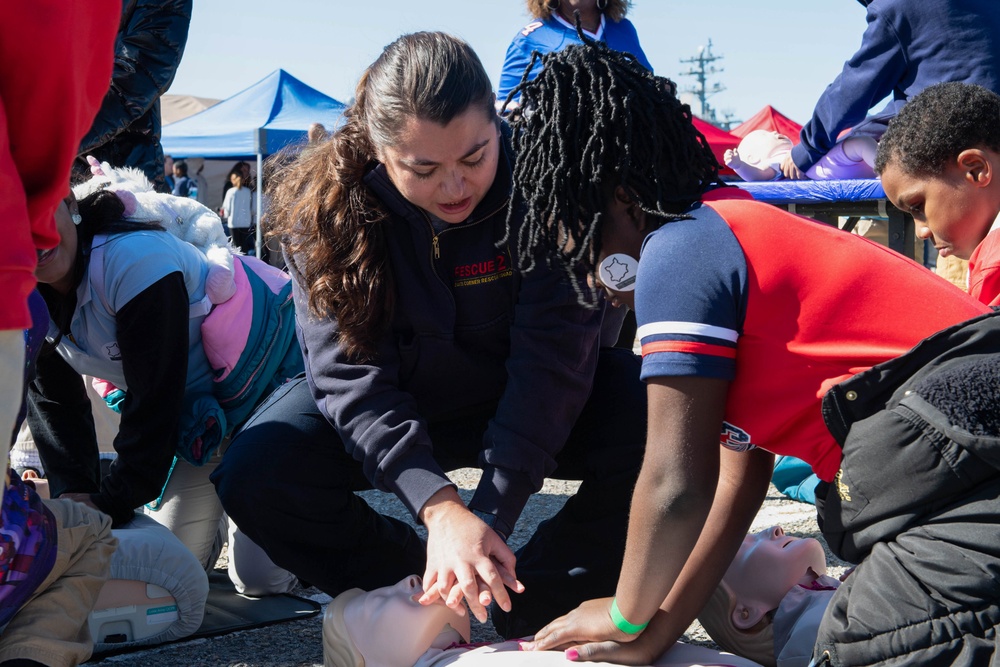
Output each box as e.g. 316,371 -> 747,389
505,32 -> 721,306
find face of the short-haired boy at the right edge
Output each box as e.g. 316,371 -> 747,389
881,150 -> 1000,259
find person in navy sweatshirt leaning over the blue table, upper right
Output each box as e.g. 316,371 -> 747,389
781,0 -> 1000,178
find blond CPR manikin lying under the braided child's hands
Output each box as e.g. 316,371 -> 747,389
323,576 -> 757,667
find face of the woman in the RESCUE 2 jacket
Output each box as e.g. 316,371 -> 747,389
380,106 -> 500,224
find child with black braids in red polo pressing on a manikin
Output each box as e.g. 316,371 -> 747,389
511,42 -> 987,664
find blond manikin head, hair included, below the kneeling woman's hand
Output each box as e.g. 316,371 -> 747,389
323,575 -> 469,667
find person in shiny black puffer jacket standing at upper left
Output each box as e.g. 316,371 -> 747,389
74,0 -> 193,192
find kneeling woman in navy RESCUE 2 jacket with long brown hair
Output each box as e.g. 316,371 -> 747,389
212,33 -> 646,637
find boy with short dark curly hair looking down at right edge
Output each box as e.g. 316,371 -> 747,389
875,83 -> 1000,306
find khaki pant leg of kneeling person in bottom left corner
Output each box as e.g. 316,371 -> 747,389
0,499 -> 118,667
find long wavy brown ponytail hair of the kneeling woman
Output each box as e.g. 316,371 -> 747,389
266,32 -> 494,359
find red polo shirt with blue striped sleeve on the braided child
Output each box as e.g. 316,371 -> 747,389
635,199 -> 987,481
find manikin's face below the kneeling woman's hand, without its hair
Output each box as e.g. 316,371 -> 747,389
344,575 -> 469,667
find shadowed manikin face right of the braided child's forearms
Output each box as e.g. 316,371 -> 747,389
722,526 -> 826,629
